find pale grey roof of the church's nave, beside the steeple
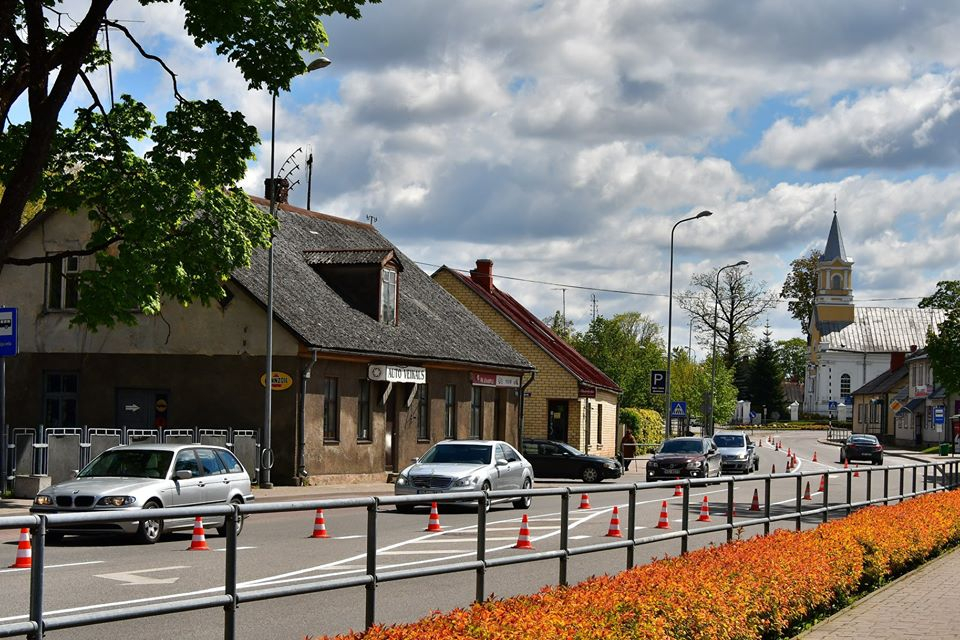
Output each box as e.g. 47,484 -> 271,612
817,307 -> 945,353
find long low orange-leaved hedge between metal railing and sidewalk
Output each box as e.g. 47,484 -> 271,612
318,491 -> 960,640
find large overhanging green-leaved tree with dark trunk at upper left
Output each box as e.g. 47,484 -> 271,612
0,0 -> 379,328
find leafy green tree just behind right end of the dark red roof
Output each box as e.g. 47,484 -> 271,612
573,312 -> 665,410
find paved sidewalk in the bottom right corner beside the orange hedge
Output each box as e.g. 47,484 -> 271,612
796,549 -> 960,640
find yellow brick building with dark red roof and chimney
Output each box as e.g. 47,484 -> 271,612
433,260 -> 622,457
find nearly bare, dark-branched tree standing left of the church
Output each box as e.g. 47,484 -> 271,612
678,267 -> 777,368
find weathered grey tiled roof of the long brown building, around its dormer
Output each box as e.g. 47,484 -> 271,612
233,197 -> 533,370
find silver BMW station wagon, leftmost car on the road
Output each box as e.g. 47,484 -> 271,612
30,444 -> 253,544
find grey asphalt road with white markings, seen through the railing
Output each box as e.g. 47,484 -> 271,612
0,432 -> 928,640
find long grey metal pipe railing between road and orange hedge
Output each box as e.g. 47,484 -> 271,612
0,461 -> 960,640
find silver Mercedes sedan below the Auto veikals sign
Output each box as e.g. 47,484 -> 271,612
394,440 -> 534,512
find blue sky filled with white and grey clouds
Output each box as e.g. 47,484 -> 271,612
37,0 -> 960,357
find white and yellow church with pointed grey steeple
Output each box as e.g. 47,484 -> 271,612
803,211 -> 944,419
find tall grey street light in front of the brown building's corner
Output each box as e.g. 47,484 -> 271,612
259,57 -> 330,489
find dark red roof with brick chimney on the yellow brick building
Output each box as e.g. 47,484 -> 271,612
440,260 -> 623,393
